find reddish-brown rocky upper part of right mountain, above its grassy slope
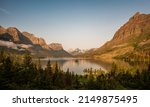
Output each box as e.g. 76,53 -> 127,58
97,12 -> 150,56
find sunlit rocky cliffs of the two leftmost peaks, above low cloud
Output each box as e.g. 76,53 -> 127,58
0,27 -> 49,49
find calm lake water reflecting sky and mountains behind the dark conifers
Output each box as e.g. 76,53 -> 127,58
34,58 -> 147,75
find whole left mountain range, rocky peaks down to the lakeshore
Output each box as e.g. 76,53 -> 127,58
0,26 -> 72,57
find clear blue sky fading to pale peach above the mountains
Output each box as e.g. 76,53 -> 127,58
0,0 -> 150,50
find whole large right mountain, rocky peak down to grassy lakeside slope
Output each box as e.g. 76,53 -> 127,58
85,12 -> 150,60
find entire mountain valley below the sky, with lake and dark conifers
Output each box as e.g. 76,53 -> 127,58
0,12 -> 150,90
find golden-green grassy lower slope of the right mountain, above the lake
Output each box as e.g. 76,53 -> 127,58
94,35 -> 150,61
